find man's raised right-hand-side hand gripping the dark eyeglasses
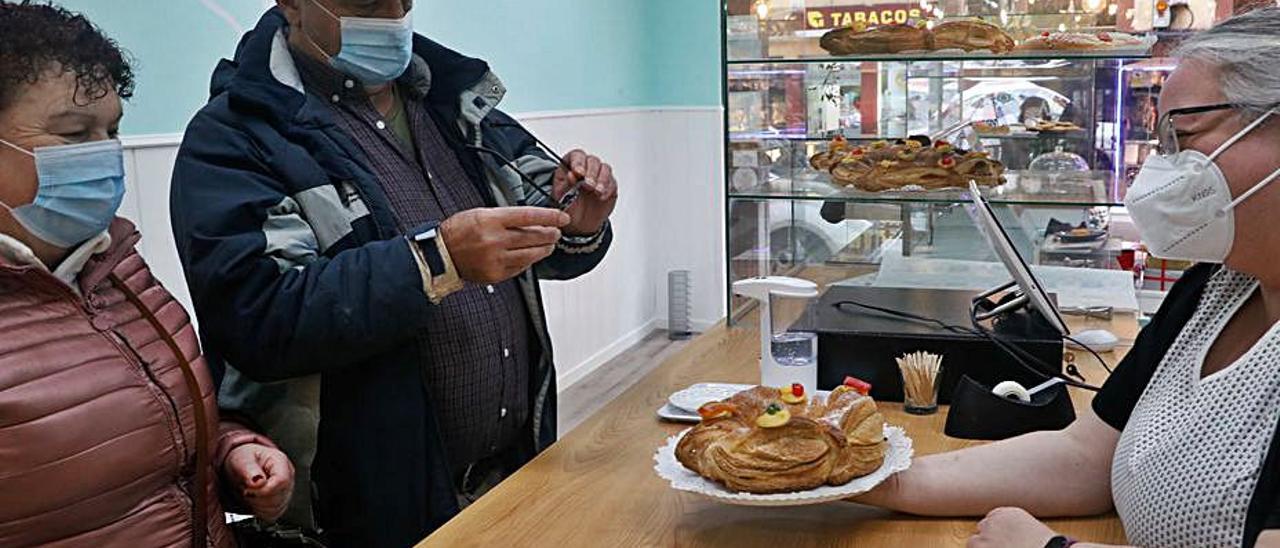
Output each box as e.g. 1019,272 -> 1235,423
552,150 -> 618,236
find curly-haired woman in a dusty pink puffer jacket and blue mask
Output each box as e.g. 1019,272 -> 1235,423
0,0 -> 293,547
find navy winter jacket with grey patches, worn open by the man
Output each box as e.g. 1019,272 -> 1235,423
172,9 -> 612,547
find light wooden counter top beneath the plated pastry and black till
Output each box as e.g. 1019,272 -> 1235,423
422,316 -> 1138,548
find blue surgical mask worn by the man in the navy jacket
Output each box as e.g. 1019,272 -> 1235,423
303,0 -> 413,86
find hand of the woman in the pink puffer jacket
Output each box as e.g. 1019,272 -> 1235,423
223,443 -> 293,522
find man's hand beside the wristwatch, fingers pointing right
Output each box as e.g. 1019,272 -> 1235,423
440,207 -> 570,283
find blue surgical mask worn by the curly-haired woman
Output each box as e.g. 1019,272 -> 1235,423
0,140 -> 124,250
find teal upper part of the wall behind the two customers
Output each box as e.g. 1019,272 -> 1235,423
45,0 -> 719,134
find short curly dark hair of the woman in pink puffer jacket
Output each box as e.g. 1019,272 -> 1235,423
0,0 -> 133,111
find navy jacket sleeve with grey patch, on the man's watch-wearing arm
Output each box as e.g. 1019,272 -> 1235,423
170,108 -> 431,382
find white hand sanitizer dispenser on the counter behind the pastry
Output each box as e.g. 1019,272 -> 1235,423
733,277 -> 818,394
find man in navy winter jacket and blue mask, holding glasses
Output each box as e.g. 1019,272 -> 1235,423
172,0 -> 617,545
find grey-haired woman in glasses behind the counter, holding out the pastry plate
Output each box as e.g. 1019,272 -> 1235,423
859,8 -> 1280,548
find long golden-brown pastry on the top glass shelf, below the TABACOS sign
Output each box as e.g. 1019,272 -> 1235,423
819,19 -> 1014,55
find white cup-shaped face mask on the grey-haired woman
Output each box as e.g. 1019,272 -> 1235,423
1125,109 -> 1280,262
